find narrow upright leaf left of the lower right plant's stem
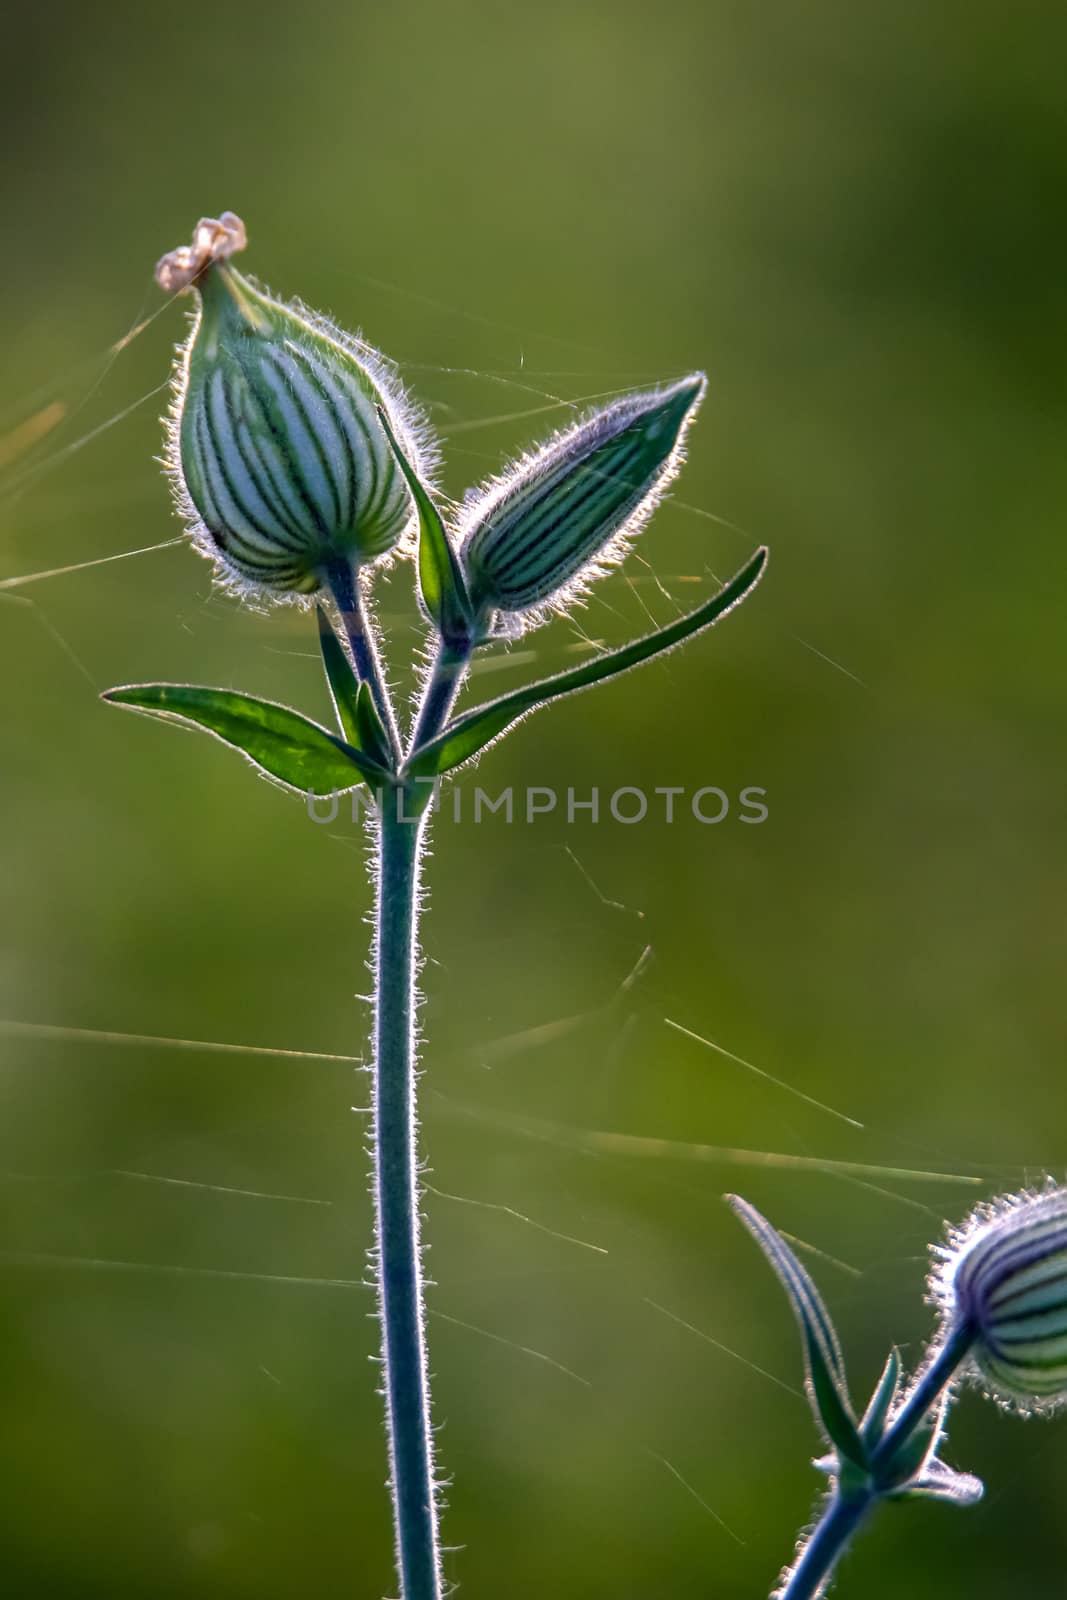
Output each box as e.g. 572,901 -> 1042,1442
726,1195 -> 867,1467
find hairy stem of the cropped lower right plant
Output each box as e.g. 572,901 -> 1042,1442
774,1323 -> 974,1600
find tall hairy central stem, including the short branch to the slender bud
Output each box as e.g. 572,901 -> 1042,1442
374,630 -> 470,1600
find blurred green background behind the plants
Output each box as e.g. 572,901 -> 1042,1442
0,0 -> 1067,1600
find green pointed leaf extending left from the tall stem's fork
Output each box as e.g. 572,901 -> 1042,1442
101,683 -> 389,795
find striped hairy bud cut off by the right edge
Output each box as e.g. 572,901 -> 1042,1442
931,1189 -> 1067,1413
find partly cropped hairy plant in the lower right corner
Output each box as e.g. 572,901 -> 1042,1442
728,1184 -> 1067,1600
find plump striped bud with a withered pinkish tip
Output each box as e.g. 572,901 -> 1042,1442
155,211 -> 427,595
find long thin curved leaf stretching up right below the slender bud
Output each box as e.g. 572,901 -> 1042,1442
408,547 -> 766,776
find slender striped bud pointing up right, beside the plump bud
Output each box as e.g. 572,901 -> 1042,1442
459,373 -> 705,632
